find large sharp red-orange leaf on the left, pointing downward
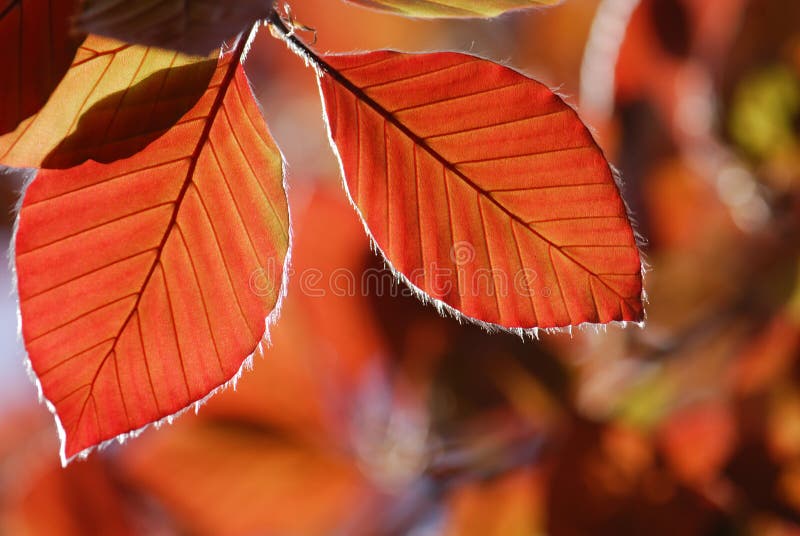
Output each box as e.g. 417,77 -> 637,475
15,37 -> 289,463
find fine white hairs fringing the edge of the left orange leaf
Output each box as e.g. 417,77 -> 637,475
8,25 -> 293,467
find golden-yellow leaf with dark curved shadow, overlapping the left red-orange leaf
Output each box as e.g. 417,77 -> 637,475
0,36 -> 216,168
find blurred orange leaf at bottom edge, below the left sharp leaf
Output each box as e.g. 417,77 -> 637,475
124,421 -> 372,536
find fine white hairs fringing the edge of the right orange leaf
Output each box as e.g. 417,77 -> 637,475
312,50 -> 650,341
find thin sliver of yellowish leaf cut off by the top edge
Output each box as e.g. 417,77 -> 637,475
340,0 -> 560,18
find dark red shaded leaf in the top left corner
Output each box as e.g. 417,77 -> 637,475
0,0 -> 79,135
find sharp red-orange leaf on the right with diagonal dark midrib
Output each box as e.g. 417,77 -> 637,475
320,52 -> 643,329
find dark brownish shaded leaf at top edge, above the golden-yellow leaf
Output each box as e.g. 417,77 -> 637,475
75,0 -> 271,55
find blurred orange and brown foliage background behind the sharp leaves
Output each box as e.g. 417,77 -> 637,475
0,0 -> 800,536
